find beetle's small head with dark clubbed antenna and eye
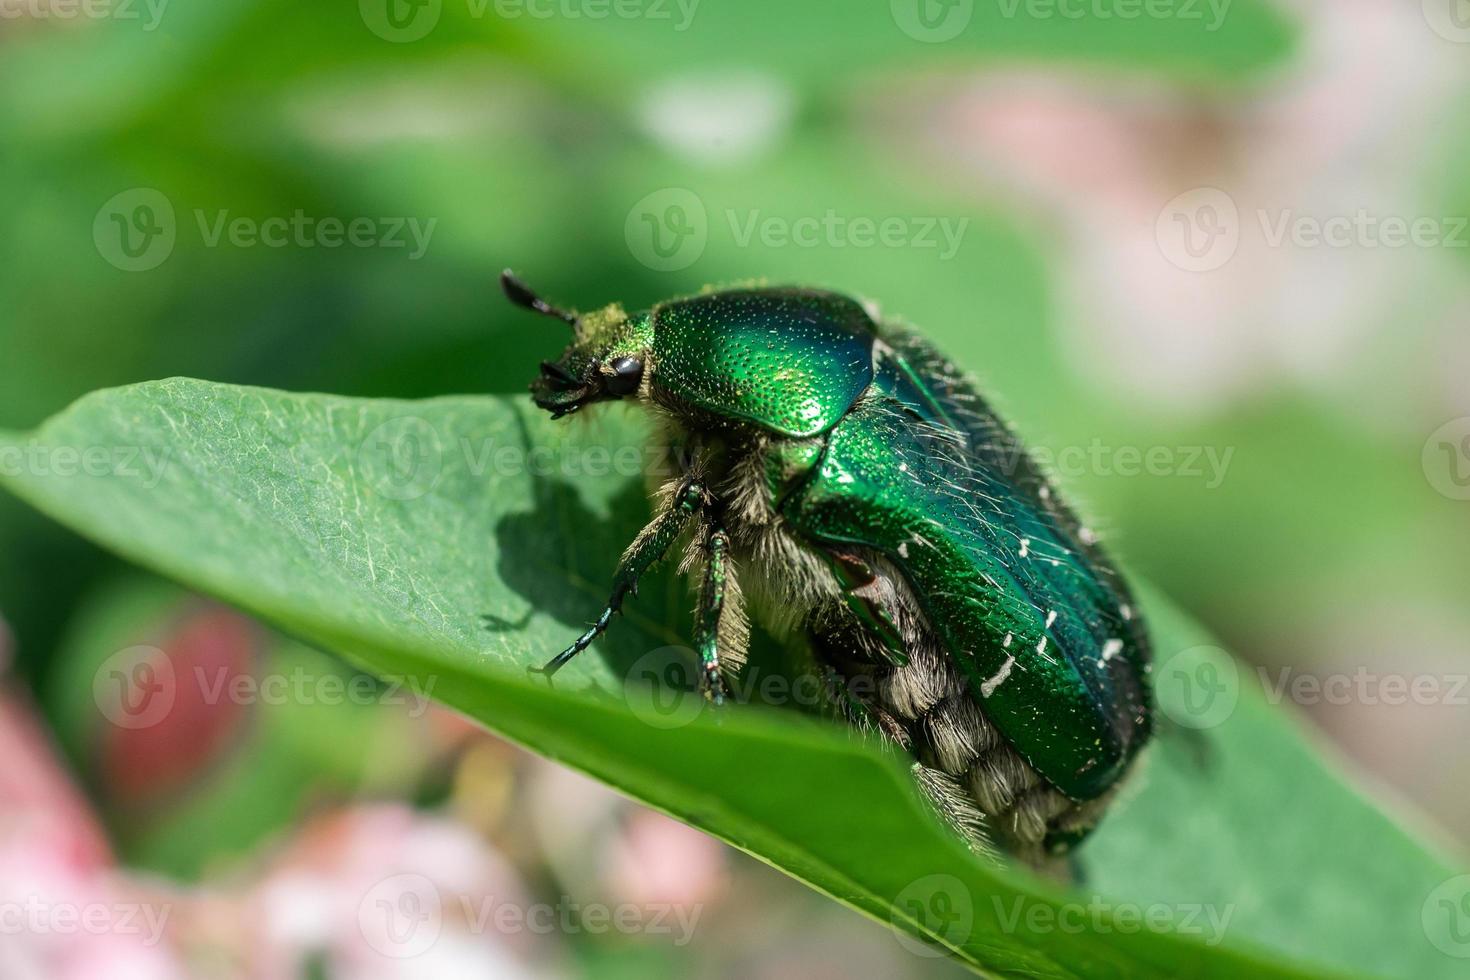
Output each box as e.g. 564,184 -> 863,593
500,269 -> 648,419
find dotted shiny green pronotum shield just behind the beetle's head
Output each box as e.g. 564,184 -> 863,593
653,289 -> 873,438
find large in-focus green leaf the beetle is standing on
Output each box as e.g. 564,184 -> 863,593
0,379 -> 1463,977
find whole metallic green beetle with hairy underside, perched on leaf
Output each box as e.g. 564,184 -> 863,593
501,272 -> 1152,864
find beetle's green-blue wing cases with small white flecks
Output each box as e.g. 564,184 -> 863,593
782,328 -> 1150,799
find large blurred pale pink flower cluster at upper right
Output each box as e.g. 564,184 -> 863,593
905,0 -> 1470,426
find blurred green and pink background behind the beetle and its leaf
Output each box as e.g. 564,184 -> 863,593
0,0 -> 1470,979
